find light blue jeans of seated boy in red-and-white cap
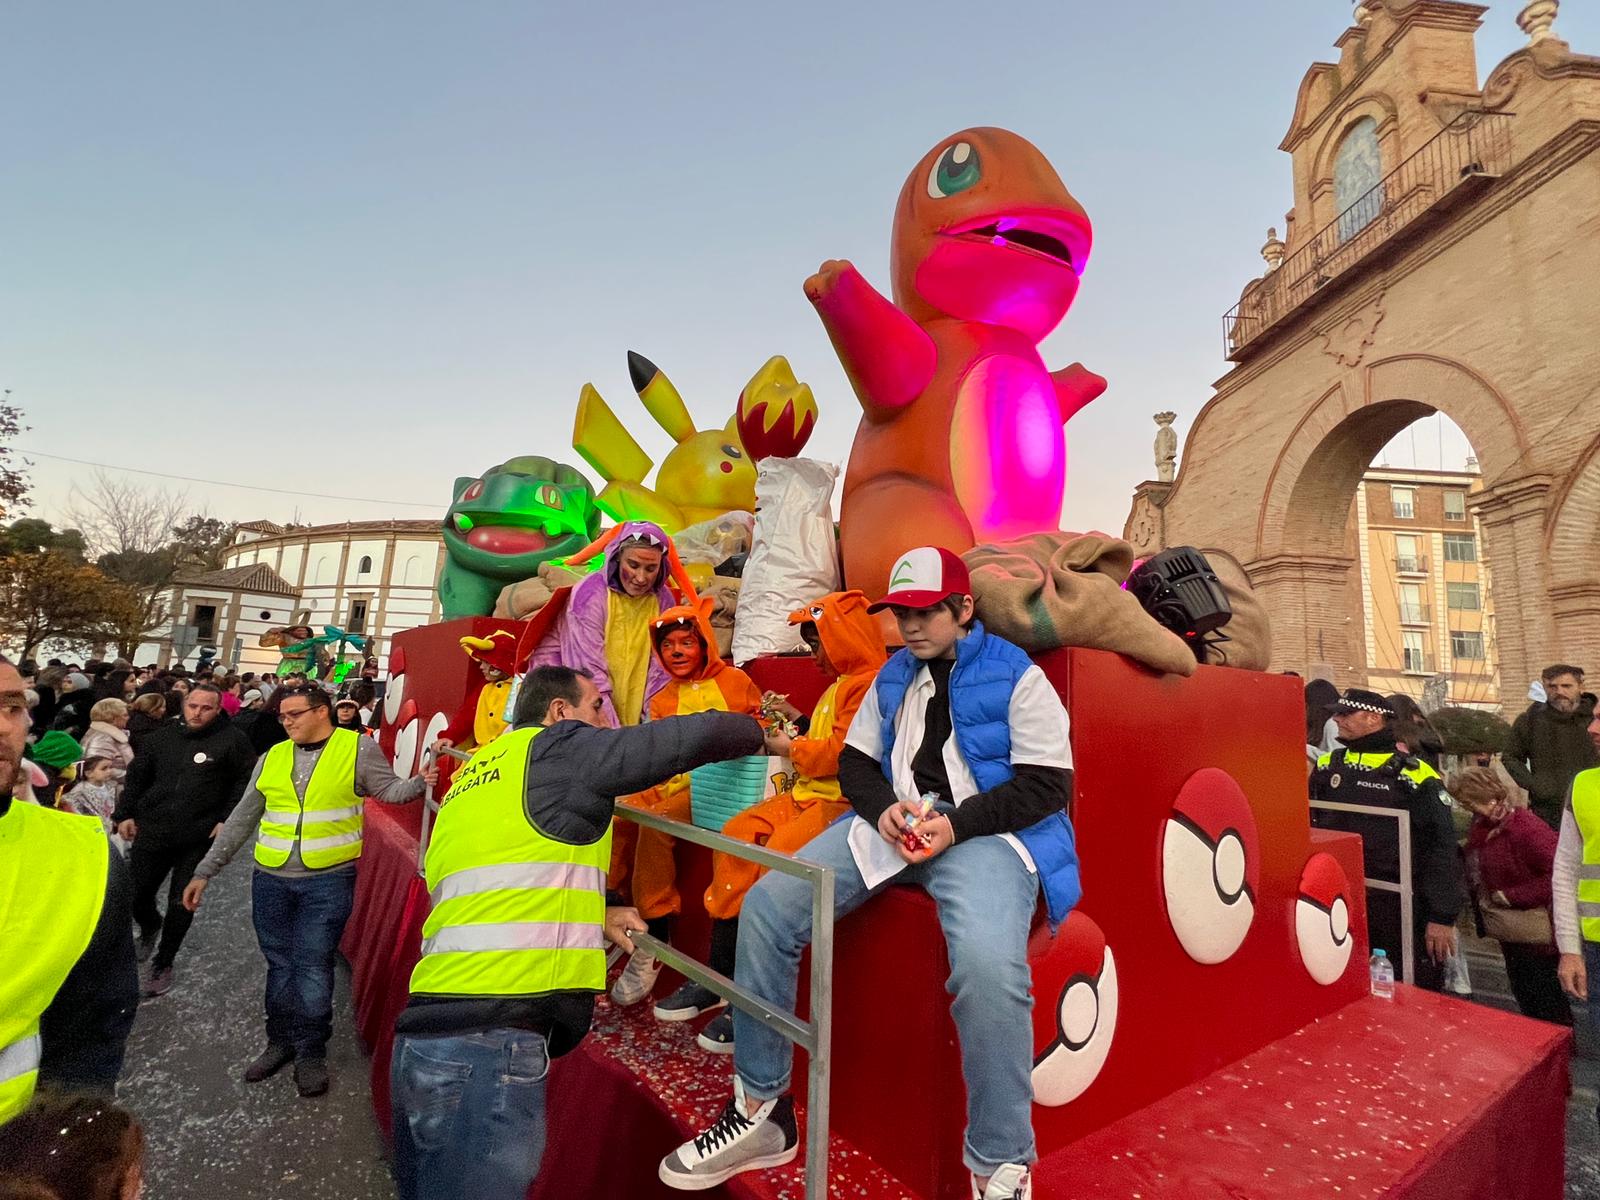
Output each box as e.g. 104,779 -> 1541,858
733,821 -> 1038,1174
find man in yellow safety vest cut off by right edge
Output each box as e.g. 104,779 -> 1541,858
1550,704 -> 1600,1117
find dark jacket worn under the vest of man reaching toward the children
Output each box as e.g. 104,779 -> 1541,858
406,712 -> 762,1058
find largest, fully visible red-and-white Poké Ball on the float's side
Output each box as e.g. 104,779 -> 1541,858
1162,766 -> 1261,965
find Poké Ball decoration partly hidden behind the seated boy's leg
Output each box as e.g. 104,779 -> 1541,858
1034,912 -> 1117,1107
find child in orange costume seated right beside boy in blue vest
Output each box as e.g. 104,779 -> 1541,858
656,592 -> 886,1054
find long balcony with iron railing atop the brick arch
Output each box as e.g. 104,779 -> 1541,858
1222,112 -> 1514,362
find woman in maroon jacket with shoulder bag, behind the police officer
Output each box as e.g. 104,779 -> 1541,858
1450,766 -> 1573,1027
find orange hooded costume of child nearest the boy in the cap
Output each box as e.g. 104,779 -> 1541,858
706,592 -> 886,918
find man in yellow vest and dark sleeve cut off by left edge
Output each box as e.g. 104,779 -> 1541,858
0,659 -> 139,1122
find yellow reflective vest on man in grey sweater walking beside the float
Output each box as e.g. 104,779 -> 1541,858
256,730 -> 363,870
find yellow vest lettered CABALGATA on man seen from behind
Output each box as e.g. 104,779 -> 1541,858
411,728 -> 611,997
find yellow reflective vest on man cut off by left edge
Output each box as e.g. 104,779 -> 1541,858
0,800 -> 110,1122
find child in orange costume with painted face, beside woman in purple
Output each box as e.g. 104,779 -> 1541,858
608,597 -> 762,1005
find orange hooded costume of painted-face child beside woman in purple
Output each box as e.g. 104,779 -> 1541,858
608,597 -> 761,920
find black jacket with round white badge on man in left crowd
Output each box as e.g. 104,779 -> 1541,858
112,712 -> 256,845
